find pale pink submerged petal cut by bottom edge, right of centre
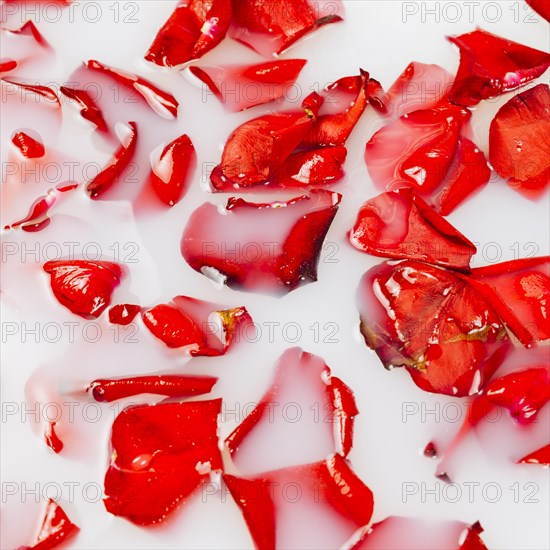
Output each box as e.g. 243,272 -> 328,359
352,516 -> 486,550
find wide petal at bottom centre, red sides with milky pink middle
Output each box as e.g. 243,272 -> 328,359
226,455 -> 374,548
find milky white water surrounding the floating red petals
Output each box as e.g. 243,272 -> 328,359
0,0 -> 550,550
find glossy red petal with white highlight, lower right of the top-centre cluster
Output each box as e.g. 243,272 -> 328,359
267,147 -> 347,189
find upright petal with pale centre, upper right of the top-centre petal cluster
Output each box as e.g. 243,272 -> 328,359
303,70 -> 378,147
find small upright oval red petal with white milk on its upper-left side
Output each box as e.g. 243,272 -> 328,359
149,134 -> 197,206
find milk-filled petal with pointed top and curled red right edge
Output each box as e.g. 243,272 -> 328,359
226,348 -> 358,473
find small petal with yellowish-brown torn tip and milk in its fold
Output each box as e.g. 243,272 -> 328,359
172,296 -> 255,356
